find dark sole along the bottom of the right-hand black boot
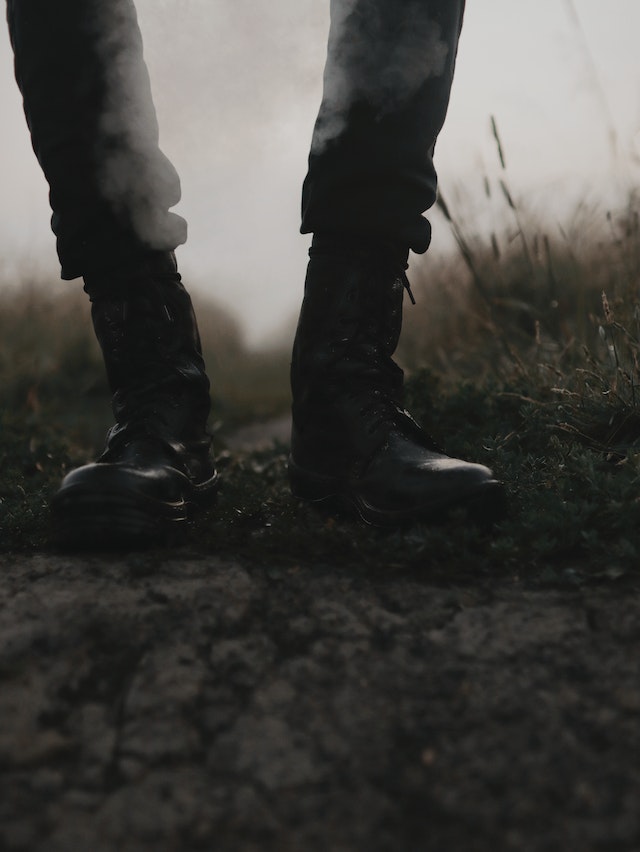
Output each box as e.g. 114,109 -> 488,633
289,458 -> 507,527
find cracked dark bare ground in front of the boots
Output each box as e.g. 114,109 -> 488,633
0,550 -> 640,852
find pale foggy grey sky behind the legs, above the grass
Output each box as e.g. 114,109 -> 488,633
0,0 -> 640,345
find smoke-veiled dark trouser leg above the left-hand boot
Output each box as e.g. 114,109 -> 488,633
7,0 -> 186,279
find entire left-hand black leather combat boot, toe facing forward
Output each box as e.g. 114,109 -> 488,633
51,253 -> 218,546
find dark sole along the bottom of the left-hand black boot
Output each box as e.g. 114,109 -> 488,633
51,474 -> 219,550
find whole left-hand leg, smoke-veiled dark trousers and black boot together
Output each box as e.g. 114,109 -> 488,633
8,0 -> 218,547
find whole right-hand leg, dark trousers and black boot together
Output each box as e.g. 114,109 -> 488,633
289,0 -> 504,525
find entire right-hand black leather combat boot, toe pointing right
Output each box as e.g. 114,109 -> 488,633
289,238 -> 505,526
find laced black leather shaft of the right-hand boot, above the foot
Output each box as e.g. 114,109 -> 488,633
291,243 -> 416,472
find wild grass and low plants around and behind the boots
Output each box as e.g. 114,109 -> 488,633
0,161 -> 640,583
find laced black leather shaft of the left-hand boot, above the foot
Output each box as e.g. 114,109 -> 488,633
85,253 -> 210,443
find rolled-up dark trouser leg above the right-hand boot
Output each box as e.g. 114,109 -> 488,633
302,0 -> 465,252
